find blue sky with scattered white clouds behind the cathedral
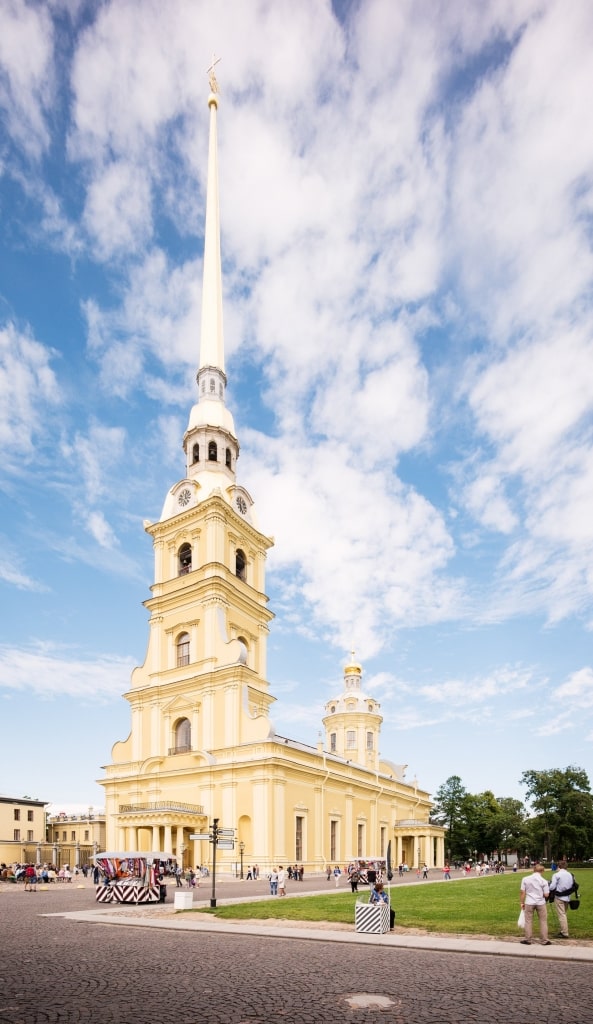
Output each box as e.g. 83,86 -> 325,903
0,0 -> 593,806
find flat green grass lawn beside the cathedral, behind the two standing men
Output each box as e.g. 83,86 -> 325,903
193,869 -> 593,939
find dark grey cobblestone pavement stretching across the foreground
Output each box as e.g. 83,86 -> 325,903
0,880 -> 593,1024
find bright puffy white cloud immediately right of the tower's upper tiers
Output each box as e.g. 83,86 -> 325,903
242,432 -> 458,657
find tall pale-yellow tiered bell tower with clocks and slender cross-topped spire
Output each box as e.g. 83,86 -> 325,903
105,64 -> 274,815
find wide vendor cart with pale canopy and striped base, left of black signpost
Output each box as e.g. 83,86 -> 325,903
94,850 -> 175,903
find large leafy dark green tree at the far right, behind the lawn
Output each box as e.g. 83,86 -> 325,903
520,765 -> 593,860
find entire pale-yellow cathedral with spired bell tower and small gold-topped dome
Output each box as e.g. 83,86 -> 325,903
99,74 -> 444,872
